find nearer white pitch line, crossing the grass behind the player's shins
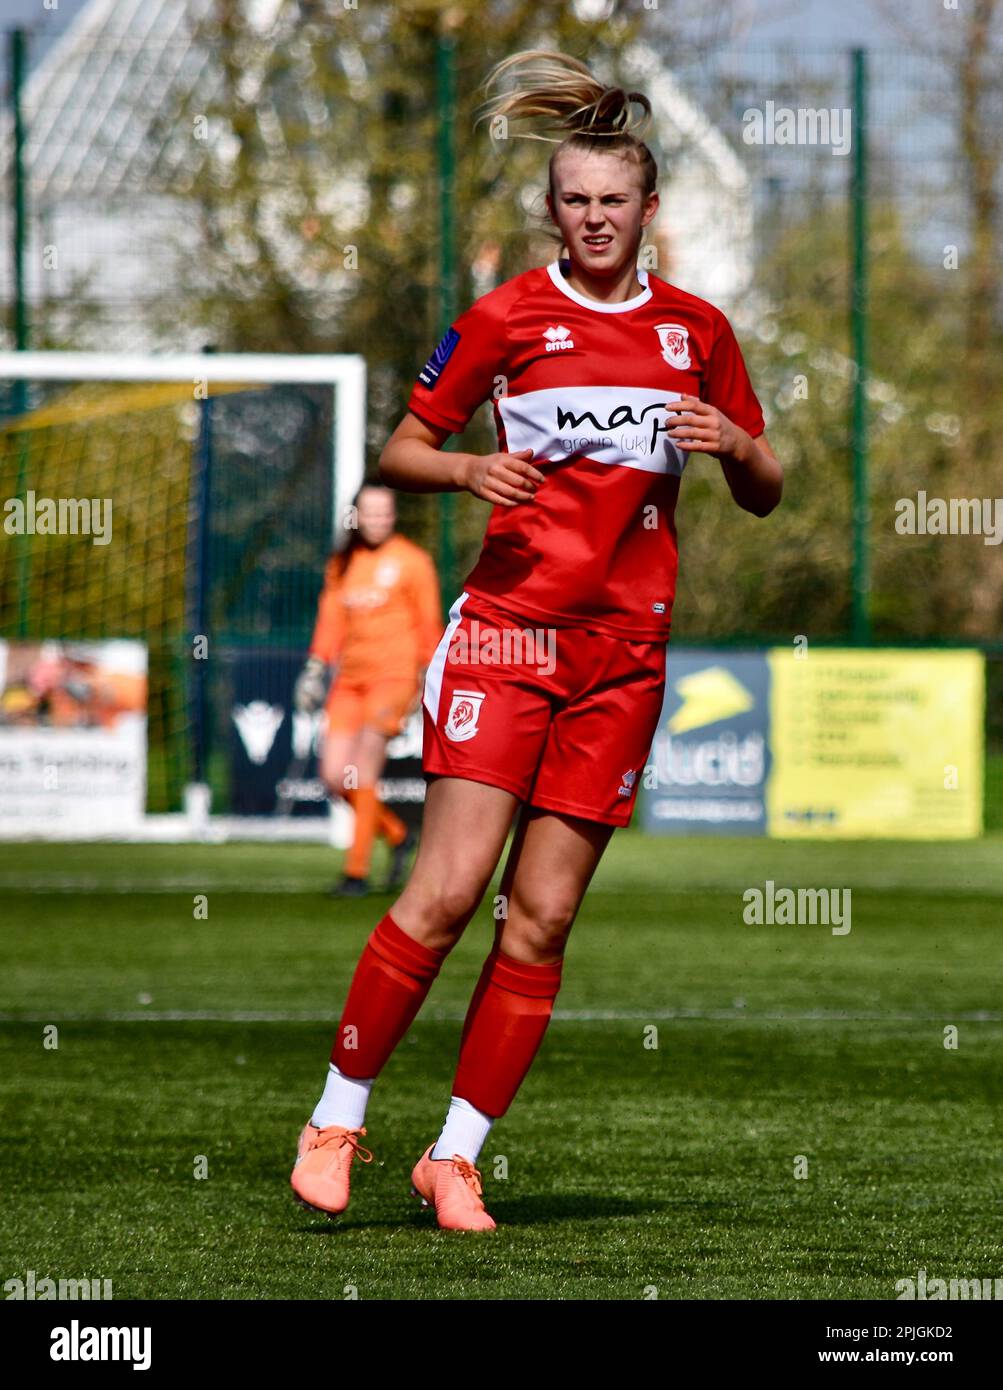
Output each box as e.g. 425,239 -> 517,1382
0,1009 -> 1003,1024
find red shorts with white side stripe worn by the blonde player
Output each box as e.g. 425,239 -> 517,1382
422,592 -> 665,826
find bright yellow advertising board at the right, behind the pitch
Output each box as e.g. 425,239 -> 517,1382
765,648 -> 985,840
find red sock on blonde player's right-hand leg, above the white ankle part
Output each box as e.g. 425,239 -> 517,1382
450,949 -> 564,1119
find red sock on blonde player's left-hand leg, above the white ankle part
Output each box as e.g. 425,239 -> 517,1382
331,912 -> 449,1077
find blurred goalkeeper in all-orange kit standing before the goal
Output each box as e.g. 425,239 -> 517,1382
293,482 -> 442,897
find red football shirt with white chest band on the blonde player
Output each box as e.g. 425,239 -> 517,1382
407,261 -> 764,641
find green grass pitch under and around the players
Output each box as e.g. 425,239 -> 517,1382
0,831 -> 1003,1300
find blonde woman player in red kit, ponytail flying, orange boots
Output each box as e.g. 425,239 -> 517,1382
292,50 -> 782,1230
